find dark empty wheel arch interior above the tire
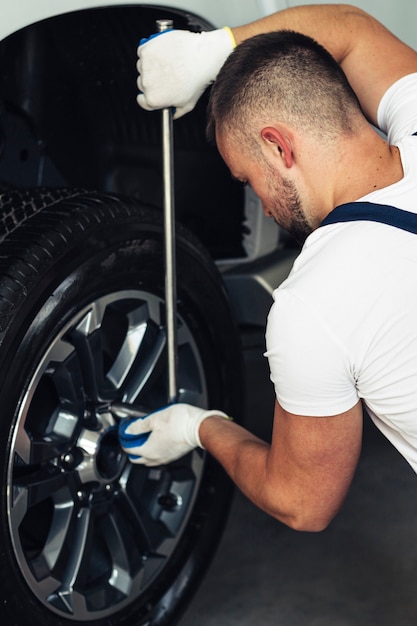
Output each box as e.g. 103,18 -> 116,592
0,5 -> 244,258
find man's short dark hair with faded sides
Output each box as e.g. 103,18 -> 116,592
207,30 -> 363,145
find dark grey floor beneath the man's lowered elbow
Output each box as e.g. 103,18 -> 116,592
180,326 -> 417,626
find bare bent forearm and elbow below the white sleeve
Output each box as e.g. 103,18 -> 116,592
200,403 -> 362,531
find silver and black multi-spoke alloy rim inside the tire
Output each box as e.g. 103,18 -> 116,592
7,291 -> 207,621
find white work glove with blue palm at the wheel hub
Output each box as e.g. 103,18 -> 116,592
119,404 -> 230,467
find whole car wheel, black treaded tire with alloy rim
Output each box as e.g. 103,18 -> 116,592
0,190 -> 241,626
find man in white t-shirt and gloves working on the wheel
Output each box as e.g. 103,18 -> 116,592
121,5 -> 417,531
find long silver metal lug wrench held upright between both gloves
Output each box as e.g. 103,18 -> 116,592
156,20 -> 177,403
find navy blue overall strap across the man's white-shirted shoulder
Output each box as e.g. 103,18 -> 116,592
320,202 -> 417,235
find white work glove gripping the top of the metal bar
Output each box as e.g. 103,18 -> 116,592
137,26 -> 236,119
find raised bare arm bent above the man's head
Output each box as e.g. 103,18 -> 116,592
233,4 -> 417,124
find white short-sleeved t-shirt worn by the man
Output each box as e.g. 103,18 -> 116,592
265,74 -> 417,472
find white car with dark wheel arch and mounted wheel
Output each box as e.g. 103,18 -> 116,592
0,0 -> 417,626
